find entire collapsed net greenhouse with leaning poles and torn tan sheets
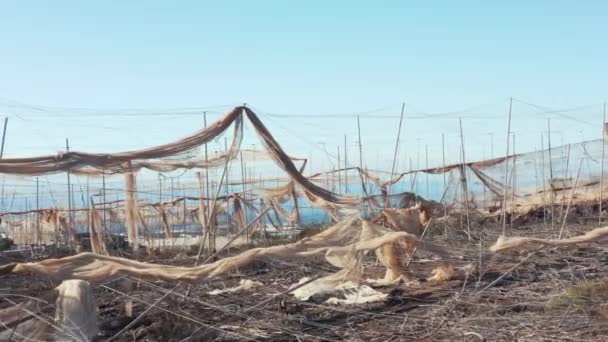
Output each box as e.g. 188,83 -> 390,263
0,106 -> 608,340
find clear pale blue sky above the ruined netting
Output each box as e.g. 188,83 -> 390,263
0,0 -> 608,174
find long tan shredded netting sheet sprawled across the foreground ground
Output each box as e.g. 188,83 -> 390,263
0,217 -> 452,286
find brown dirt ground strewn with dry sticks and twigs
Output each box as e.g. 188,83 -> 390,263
0,218 -> 608,341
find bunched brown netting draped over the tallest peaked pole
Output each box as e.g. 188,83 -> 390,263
0,107 -> 360,205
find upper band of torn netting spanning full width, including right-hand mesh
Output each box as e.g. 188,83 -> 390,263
0,106 -> 605,219
